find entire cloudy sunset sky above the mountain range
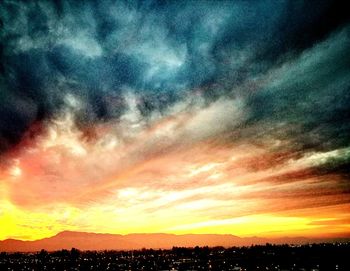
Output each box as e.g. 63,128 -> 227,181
0,0 -> 350,240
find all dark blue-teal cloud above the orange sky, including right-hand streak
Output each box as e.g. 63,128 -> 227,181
0,1 -> 350,154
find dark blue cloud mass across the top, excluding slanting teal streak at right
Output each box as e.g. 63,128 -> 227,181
0,1 -> 346,150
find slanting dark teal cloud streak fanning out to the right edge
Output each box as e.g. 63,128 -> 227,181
246,27 -> 350,149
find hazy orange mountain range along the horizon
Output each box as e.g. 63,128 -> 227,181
0,231 -> 350,252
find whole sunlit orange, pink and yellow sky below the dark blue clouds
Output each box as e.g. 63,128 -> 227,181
0,96 -> 350,240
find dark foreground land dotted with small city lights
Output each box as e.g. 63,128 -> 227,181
0,243 -> 350,271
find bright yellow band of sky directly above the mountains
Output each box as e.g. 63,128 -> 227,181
0,198 -> 350,240
